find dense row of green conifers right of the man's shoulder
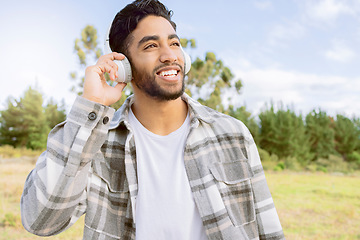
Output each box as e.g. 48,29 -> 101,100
239,104 -> 360,172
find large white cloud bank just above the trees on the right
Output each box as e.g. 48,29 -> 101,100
232,64 -> 360,116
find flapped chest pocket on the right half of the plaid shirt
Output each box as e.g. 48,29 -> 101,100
210,160 -> 255,226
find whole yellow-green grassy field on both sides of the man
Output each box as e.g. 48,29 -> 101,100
0,160 -> 360,240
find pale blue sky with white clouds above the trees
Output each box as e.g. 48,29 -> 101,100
0,0 -> 360,117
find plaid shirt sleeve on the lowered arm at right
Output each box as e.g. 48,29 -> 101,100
247,126 -> 285,240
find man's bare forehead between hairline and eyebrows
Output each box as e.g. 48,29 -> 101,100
131,16 -> 176,44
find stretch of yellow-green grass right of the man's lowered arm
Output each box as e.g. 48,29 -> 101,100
266,172 -> 360,240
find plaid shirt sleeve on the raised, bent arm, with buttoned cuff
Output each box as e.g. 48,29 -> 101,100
20,97 -> 115,236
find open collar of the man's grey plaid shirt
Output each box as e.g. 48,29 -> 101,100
110,93 -> 214,129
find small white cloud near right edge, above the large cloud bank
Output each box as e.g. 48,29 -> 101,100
325,41 -> 356,62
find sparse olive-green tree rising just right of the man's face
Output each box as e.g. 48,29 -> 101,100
180,38 -> 255,130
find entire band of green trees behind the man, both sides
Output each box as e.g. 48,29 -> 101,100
0,25 -> 360,171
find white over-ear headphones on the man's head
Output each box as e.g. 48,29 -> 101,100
104,24 -> 191,83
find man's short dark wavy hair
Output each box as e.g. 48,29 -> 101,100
109,0 -> 176,55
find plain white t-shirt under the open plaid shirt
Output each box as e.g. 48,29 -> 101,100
129,111 -> 207,240
